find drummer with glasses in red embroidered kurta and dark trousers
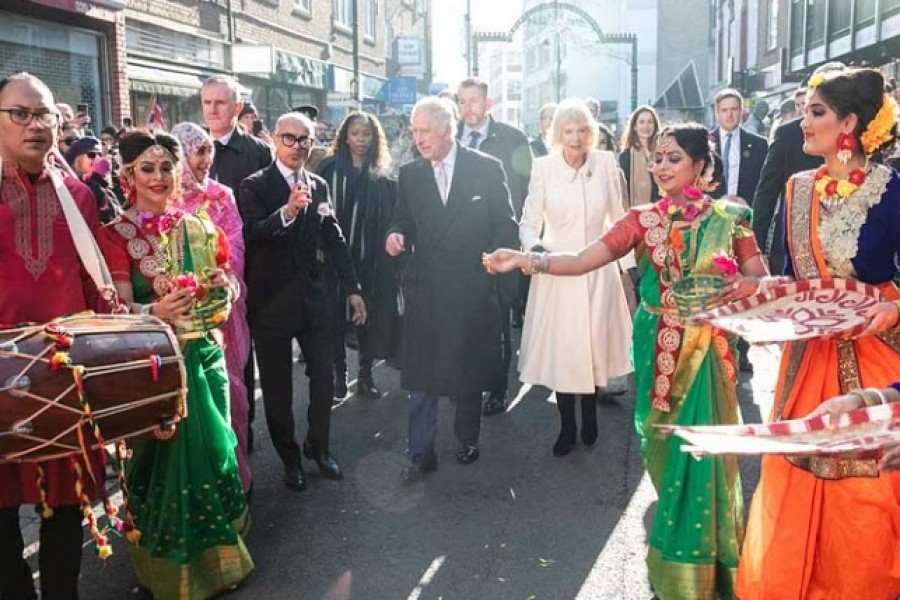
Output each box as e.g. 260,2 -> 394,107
0,73 -> 103,600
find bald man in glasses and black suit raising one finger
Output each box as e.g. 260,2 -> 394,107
239,112 -> 366,490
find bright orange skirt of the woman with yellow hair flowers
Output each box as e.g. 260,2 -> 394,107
735,337 -> 900,600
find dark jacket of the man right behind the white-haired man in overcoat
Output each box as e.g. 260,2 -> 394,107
456,116 -> 534,219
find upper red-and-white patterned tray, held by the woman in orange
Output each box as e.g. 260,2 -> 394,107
693,279 -> 881,344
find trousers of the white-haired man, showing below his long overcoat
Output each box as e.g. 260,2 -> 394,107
408,392 -> 481,456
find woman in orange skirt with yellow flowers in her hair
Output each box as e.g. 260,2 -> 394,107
735,69 -> 900,600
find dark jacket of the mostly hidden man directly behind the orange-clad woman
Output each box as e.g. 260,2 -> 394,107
753,118 -> 822,274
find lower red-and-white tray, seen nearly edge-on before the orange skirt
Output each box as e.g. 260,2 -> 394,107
658,404 -> 900,456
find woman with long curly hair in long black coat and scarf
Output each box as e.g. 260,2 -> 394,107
317,112 -> 397,398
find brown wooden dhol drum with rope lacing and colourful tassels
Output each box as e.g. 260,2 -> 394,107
0,313 -> 187,462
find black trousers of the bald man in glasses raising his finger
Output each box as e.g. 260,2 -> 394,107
253,319 -> 334,467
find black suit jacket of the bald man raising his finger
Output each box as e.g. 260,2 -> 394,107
238,163 -> 360,329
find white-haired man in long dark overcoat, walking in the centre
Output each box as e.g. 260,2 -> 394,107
385,97 -> 518,481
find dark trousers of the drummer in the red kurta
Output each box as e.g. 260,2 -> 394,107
0,506 -> 83,600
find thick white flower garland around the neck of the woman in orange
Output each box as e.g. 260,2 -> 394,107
818,165 -> 891,277
